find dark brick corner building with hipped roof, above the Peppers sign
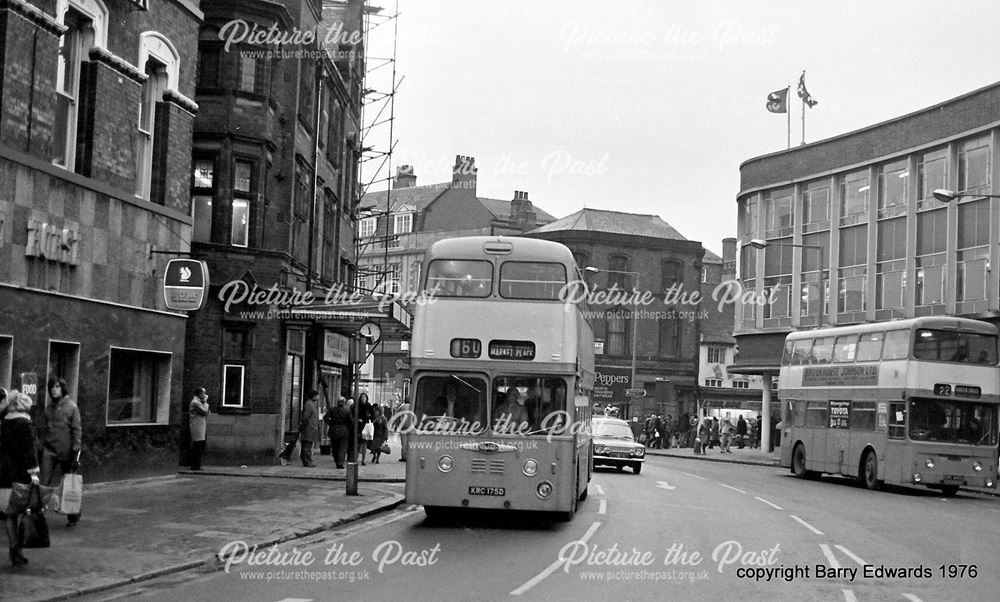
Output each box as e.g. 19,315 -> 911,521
526,209 -> 703,418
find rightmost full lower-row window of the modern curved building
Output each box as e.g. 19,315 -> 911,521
956,199 -> 992,301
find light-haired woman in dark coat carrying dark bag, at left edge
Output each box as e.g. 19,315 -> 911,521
0,389 -> 40,568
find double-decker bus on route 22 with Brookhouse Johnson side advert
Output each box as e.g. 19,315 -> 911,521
778,317 -> 1000,495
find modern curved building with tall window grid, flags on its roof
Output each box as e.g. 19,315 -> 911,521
731,82 -> 1000,390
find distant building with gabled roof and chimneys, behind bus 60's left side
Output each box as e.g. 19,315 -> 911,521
358,155 -> 555,403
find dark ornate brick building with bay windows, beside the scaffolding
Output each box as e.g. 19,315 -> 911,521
185,0 -> 392,460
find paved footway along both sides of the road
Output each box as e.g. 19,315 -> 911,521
0,435 -> 996,601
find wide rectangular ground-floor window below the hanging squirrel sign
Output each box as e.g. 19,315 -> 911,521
107,347 -> 170,425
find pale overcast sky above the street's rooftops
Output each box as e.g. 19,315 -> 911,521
366,0 -> 1000,253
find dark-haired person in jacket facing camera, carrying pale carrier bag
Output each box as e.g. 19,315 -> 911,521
41,377 -> 83,527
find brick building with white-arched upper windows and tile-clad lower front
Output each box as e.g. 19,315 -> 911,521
0,0 -> 202,480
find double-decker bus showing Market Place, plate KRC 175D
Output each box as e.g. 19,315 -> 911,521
406,236 -> 594,520
